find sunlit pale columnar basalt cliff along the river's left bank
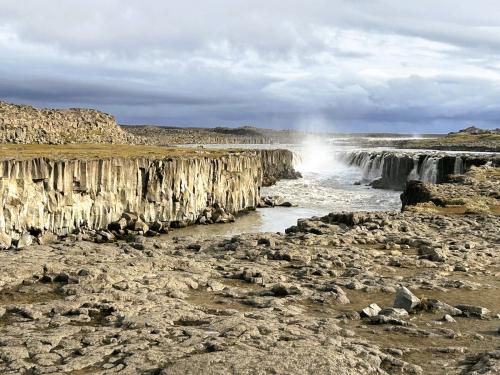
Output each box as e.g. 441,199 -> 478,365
0,150 -> 293,242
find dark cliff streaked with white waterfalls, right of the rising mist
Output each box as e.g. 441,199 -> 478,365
340,151 -> 500,190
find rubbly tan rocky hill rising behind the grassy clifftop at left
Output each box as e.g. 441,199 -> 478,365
0,101 -> 145,144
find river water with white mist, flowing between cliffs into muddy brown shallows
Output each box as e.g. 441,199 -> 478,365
170,142 -> 401,237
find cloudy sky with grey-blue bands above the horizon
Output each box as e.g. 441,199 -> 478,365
0,0 -> 500,133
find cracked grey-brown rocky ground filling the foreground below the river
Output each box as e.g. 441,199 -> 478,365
0,212 -> 500,374
